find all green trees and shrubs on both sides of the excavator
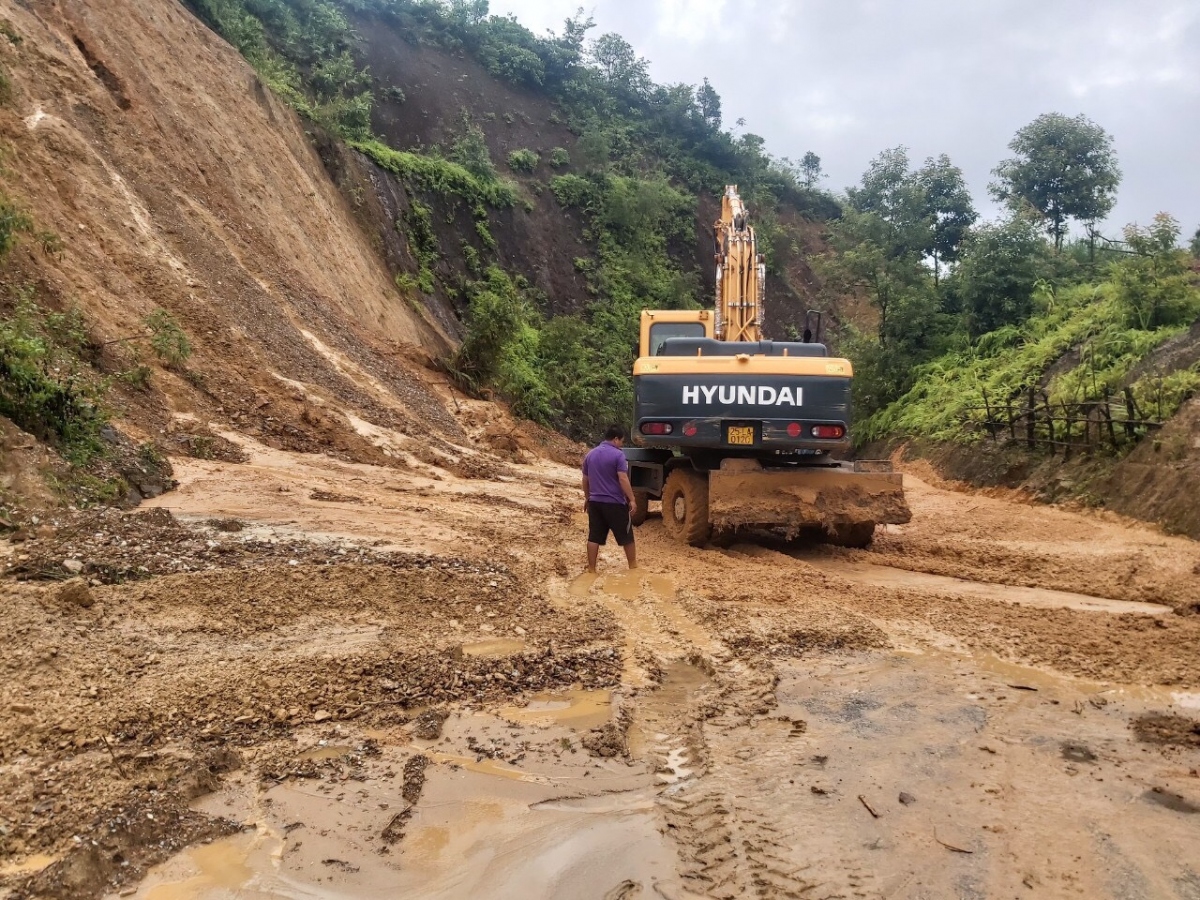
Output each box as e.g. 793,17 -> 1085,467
185,0 -> 1200,458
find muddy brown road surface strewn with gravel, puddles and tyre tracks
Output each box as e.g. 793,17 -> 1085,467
0,436 -> 1200,900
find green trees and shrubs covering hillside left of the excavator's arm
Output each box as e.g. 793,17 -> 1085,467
185,0 -> 840,437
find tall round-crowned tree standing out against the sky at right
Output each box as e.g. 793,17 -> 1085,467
989,113 -> 1121,251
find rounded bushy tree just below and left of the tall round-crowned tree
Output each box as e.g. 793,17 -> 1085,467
948,216 -> 1049,337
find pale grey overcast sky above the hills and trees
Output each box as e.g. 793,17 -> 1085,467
491,0 -> 1200,239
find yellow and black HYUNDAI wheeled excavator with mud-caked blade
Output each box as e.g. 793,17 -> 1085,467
625,185 -> 912,547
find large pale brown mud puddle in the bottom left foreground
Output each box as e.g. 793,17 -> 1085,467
120,710 -> 686,900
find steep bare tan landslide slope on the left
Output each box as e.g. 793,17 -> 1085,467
0,0 -> 462,461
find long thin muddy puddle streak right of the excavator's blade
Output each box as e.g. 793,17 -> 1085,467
797,553 -> 1171,616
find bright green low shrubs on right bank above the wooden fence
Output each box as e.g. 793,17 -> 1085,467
858,216 -> 1200,443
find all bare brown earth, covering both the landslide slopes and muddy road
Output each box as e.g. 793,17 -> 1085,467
0,0 -> 1200,900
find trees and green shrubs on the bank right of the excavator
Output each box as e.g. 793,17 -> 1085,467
818,113 -> 1200,442
